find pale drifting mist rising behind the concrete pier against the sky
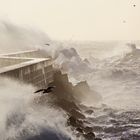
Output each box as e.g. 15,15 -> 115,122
0,21 -> 50,54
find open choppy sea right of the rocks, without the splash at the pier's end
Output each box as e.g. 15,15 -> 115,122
75,44 -> 140,140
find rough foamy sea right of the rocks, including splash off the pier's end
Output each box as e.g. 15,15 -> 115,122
52,42 -> 140,140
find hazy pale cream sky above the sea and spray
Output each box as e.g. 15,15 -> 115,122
0,0 -> 140,40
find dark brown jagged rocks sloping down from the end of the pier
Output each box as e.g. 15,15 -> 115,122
52,71 -> 101,140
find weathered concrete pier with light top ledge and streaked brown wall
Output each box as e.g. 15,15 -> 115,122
0,50 -> 53,88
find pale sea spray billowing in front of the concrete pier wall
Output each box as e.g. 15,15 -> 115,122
0,78 -> 72,140
